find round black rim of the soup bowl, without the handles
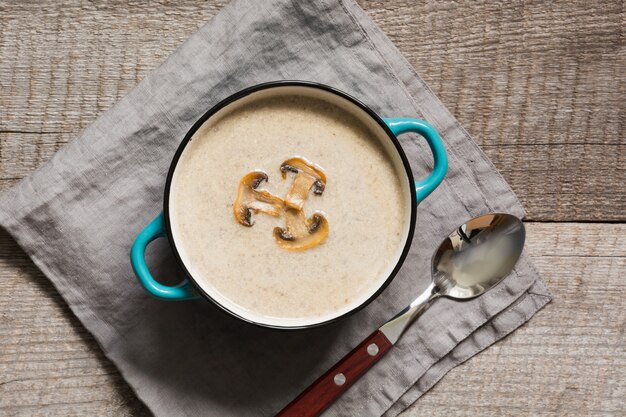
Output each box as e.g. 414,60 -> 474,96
163,80 -> 417,330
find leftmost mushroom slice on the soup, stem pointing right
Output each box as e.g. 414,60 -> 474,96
233,171 -> 285,227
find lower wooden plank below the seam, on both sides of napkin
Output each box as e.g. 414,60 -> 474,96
0,223 -> 626,417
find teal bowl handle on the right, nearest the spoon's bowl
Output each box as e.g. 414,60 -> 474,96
385,117 -> 448,204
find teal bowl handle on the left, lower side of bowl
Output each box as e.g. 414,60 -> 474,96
130,213 -> 199,300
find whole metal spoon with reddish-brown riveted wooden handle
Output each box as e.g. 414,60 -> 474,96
277,214 -> 526,417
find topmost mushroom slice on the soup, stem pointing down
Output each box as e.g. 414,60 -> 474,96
280,156 -> 326,210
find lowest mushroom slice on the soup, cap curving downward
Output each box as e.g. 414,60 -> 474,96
274,207 -> 328,251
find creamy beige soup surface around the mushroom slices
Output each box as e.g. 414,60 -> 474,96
170,94 -> 408,323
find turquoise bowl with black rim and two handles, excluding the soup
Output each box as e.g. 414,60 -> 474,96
130,81 -> 448,329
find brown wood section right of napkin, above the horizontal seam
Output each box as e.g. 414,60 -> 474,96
362,1 -> 626,221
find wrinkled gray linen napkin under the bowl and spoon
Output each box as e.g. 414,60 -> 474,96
0,0 -> 550,416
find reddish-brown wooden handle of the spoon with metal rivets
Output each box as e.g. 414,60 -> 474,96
276,330 -> 393,417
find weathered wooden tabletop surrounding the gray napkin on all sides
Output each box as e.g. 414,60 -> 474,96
0,0 -> 626,417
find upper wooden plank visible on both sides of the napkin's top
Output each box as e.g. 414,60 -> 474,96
0,0 -> 626,221
